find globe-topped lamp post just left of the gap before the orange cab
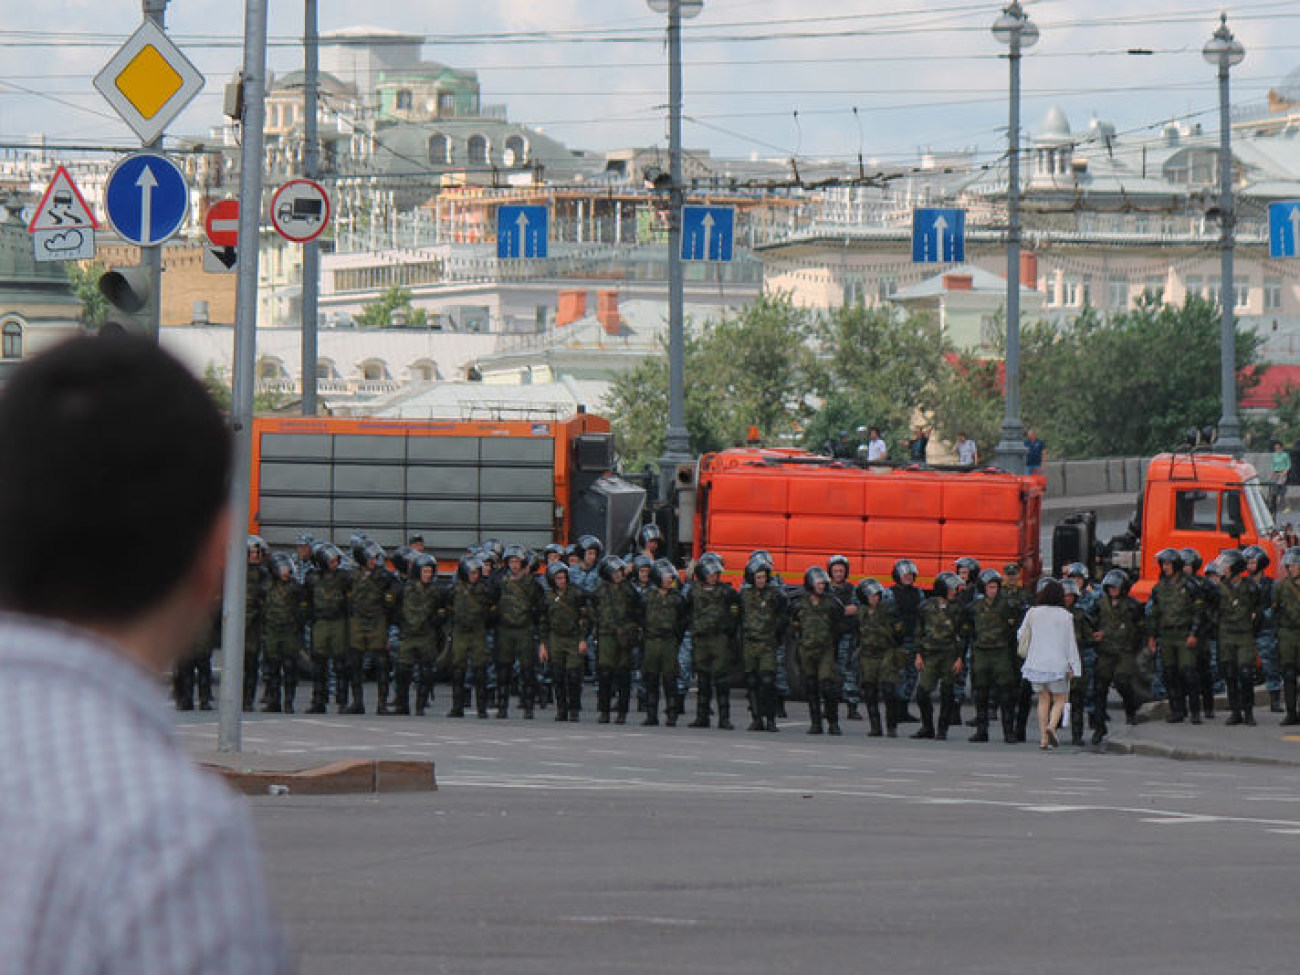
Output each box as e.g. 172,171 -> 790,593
993,0 -> 1039,473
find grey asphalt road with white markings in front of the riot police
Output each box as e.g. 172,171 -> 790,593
182,701 -> 1300,975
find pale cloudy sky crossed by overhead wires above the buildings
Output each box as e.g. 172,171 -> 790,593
0,0 -> 1300,172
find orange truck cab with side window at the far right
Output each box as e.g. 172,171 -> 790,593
1112,451 -> 1283,599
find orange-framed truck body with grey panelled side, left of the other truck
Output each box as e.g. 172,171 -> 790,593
250,412 -> 645,566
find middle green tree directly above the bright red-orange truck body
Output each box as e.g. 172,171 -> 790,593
803,303 -> 948,459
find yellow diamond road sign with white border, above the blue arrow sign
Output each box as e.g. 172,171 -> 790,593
95,21 -> 203,143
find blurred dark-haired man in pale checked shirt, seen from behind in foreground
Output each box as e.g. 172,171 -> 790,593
0,334 -> 289,975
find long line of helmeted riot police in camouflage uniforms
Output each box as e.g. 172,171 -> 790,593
174,535 -> 1300,745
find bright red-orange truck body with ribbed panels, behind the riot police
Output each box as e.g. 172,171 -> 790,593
692,449 -> 1044,582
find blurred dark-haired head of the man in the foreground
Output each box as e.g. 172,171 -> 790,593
0,335 -> 230,653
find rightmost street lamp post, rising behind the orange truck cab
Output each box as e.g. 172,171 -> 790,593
1201,13 -> 1245,454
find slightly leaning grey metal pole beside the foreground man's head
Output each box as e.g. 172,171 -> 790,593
217,0 -> 267,751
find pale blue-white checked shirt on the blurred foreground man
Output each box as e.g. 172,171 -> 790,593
0,615 -> 289,975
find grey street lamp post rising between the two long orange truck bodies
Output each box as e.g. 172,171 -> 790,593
646,0 -> 705,499
